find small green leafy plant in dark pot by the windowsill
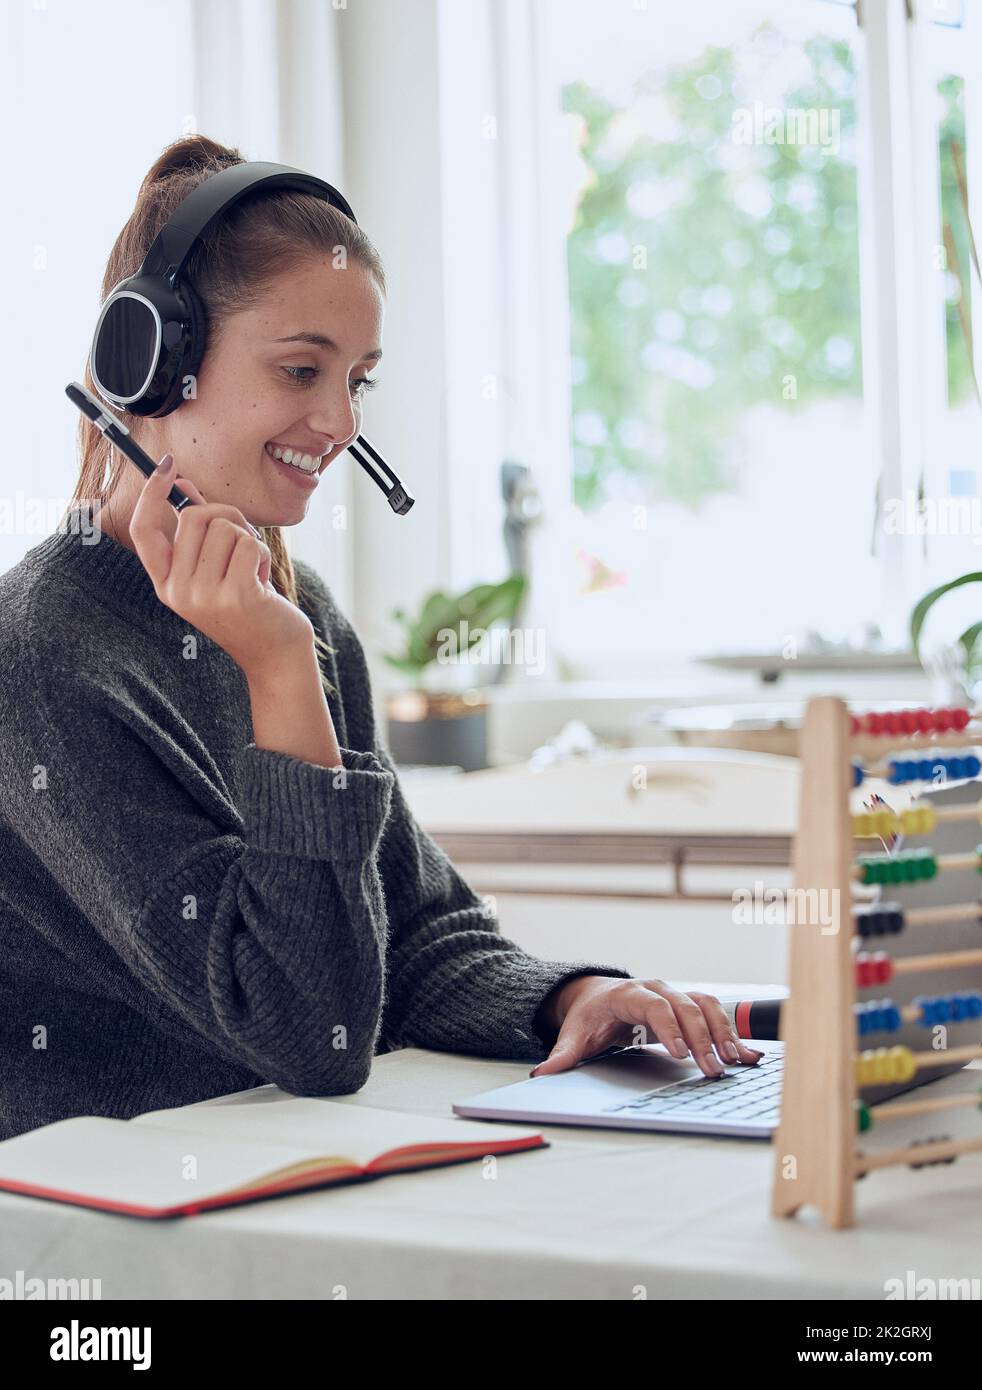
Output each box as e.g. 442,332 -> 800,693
384,574 -> 527,771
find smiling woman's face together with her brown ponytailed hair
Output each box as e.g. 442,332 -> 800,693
62,136 -> 385,686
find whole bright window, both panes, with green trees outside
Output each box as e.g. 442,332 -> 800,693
484,0 -> 982,676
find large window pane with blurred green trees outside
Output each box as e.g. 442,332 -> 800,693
522,0 -> 878,670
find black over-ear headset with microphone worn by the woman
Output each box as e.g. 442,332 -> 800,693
89,161 -> 414,513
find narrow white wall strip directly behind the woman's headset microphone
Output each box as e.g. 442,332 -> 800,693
338,0 -> 446,686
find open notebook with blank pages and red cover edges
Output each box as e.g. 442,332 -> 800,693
0,1088 -> 548,1216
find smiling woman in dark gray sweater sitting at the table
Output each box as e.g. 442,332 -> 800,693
0,136 -> 759,1137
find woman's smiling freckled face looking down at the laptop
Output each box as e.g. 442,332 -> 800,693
145,256 -> 384,525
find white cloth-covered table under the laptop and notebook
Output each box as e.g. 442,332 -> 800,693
0,1049 -> 982,1300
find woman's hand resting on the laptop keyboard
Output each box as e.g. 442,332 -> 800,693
529,974 -> 764,1076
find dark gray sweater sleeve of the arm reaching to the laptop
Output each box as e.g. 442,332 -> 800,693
314,589 -> 631,1062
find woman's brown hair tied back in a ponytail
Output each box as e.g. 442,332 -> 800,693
63,135 -> 385,691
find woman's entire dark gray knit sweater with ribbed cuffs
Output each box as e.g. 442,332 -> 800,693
0,511 -> 629,1138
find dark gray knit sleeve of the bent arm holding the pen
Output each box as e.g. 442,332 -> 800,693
0,635 -> 394,1095
